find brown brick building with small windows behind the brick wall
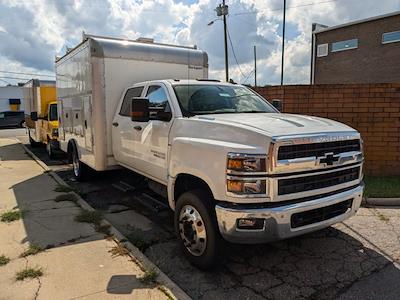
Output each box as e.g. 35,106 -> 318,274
311,11 -> 400,84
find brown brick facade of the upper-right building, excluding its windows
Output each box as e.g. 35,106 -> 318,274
314,14 -> 400,84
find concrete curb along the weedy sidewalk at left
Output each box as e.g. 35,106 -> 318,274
16,139 -> 191,300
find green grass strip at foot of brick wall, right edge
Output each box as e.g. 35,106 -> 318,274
364,176 -> 400,198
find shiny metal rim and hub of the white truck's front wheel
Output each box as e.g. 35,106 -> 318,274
179,205 -> 207,256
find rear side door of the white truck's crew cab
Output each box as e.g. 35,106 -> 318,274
112,86 -> 143,168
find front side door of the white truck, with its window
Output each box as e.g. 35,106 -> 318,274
132,84 -> 172,183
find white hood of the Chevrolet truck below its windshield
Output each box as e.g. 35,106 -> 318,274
195,113 -> 355,137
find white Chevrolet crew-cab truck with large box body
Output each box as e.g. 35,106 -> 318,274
56,34 -> 363,268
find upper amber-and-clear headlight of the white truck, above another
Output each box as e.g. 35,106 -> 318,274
226,153 -> 267,173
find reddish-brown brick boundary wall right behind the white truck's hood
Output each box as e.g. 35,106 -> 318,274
255,83 -> 400,176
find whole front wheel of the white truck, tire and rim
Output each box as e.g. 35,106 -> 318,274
174,190 -> 222,270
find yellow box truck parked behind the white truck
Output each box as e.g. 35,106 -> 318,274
23,79 -> 59,157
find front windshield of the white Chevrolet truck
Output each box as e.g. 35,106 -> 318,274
174,84 -> 277,116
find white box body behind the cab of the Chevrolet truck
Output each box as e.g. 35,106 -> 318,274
56,36 -> 208,171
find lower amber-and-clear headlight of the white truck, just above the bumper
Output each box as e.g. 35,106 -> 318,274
226,178 -> 267,195
